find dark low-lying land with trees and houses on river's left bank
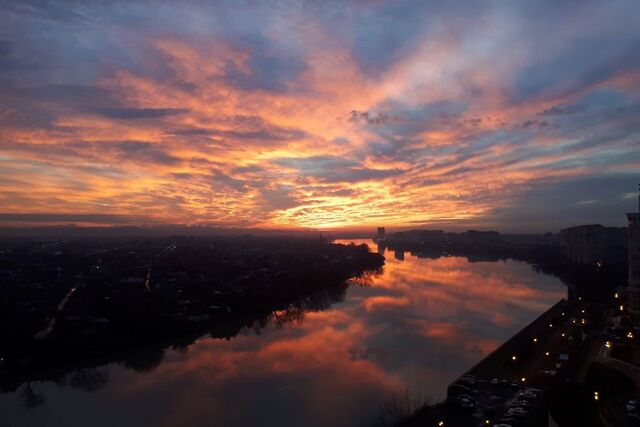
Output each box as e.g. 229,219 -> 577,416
0,236 -> 384,390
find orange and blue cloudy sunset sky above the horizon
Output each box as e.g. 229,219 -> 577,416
0,0 -> 640,231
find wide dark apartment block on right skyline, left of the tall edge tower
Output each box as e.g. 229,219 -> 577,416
560,224 -> 627,264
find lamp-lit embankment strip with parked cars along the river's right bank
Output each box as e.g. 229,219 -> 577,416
398,300 -> 579,427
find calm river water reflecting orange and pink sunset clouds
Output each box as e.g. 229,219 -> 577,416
0,241 -> 566,427
